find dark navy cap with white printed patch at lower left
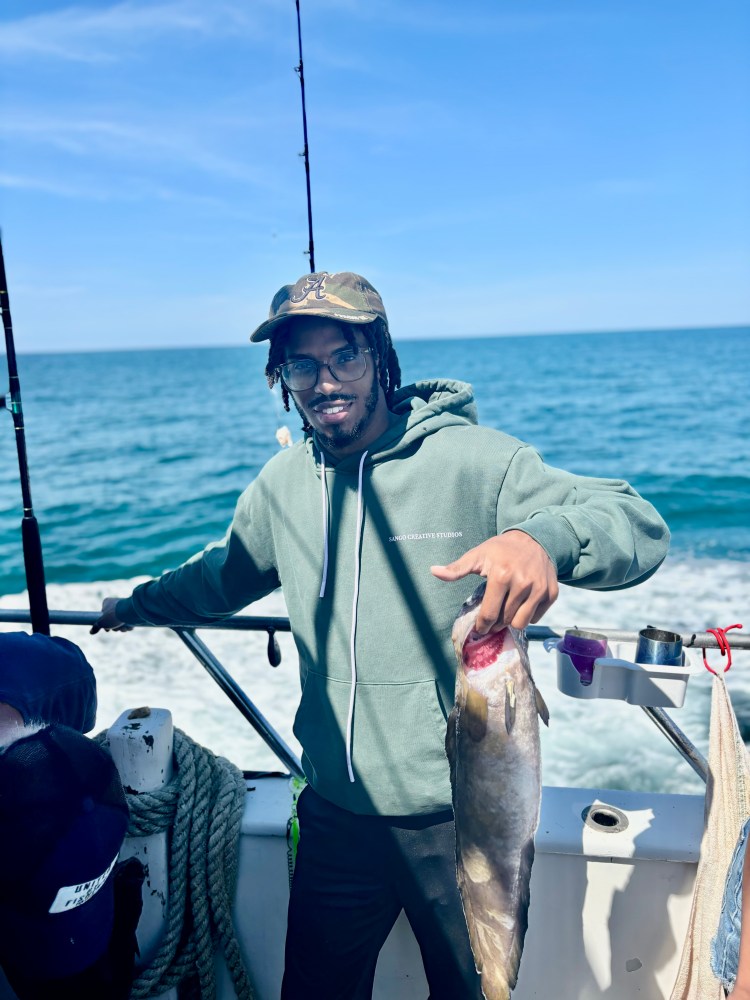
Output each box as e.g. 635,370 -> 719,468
0,726 -> 128,981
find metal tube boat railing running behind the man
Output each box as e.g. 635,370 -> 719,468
0,608 -> 750,781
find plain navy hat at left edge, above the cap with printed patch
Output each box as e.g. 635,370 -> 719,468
0,632 -> 96,733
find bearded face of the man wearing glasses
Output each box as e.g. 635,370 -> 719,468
284,316 -> 388,456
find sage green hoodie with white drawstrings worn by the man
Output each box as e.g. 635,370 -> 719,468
116,380 -> 669,815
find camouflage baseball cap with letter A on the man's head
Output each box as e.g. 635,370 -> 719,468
250,271 -> 388,343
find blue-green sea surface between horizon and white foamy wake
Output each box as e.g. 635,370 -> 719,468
0,328 -> 750,594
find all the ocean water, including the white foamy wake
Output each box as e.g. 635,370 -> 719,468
0,328 -> 750,792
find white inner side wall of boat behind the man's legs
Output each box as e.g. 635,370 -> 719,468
222,778 -> 703,1000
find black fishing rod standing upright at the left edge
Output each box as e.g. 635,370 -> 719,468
0,235 -> 50,635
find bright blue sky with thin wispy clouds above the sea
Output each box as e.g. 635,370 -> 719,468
0,0 -> 750,354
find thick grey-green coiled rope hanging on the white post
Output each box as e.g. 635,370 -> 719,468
100,729 -> 255,1000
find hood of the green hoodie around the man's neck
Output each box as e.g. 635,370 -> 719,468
306,378 -> 477,475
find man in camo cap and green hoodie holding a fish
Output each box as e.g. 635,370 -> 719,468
92,272 -> 668,1000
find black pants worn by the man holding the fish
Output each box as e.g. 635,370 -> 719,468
281,787 -> 482,1000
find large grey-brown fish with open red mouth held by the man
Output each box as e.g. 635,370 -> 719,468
446,584 -> 549,1000
